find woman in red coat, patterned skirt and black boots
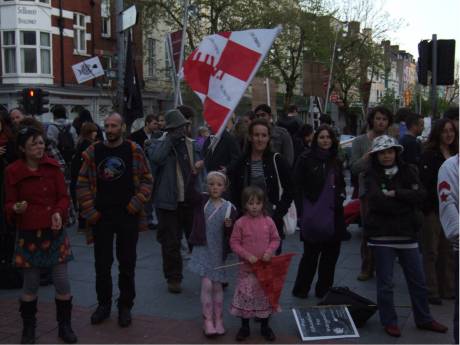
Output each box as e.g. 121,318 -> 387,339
5,127 -> 77,344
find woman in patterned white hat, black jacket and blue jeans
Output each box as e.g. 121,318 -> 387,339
364,135 -> 447,337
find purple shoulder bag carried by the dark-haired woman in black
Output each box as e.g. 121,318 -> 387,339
300,170 -> 335,243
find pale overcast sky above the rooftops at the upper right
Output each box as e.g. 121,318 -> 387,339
383,0 -> 460,60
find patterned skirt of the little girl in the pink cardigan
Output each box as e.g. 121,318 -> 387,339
230,269 -> 281,319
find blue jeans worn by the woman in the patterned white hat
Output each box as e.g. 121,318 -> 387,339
372,247 -> 433,326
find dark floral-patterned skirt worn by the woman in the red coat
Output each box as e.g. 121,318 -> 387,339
14,229 -> 73,268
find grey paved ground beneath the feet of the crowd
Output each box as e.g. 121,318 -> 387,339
0,227 -> 453,344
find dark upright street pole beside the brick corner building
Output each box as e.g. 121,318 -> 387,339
115,0 -> 126,114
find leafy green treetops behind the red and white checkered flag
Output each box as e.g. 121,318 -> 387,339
142,0 -> 331,107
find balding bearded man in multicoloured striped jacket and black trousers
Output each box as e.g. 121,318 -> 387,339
77,113 -> 153,327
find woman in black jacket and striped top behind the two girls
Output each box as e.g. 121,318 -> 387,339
228,119 -> 294,248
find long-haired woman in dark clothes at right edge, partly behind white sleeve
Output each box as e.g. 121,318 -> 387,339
419,119 -> 458,305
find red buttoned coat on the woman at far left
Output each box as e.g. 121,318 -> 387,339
5,155 -> 70,230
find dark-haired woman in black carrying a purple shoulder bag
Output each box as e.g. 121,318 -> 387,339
292,125 -> 345,298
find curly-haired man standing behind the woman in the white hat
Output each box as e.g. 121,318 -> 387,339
350,107 -> 393,281
